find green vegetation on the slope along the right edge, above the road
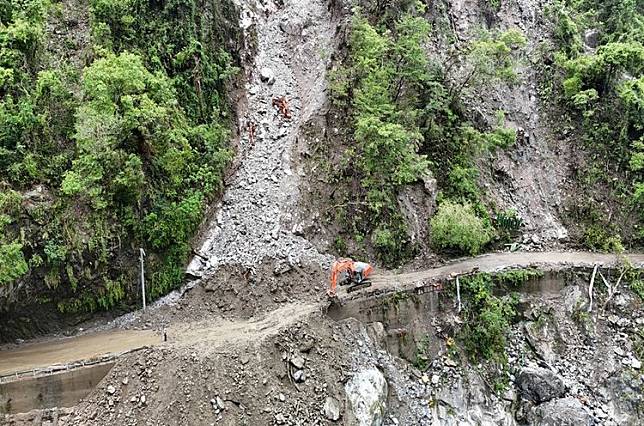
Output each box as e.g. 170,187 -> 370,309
546,0 -> 644,250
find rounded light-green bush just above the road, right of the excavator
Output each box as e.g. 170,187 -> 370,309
431,201 -> 493,255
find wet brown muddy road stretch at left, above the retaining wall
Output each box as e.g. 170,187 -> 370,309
0,330 -> 161,376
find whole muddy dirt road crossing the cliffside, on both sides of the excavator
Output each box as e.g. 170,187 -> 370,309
0,252 -> 644,376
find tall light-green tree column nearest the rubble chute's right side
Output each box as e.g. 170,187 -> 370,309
331,3 -> 429,265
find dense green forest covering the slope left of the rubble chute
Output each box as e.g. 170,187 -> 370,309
0,0 -> 236,312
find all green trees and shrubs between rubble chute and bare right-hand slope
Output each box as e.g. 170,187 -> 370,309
331,1 -> 525,266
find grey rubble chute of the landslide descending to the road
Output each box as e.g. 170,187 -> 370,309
188,0 -> 335,276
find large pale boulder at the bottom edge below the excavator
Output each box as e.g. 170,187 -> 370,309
344,368 -> 387,426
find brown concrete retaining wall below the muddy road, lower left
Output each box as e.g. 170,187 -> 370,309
0,363 -> 114,414
